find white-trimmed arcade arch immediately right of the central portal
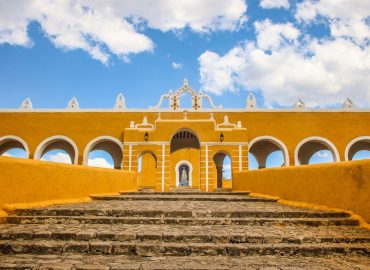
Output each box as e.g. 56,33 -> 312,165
248,136 -> 290,169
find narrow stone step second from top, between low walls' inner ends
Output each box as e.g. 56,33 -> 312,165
91,194 -> 276,202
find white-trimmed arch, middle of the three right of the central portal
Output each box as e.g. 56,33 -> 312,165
294,136 -> 340,165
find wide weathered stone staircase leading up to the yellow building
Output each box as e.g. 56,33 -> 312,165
0,190 -> 370,269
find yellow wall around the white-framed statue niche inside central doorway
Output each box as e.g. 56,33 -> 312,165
168,148 -> 200,188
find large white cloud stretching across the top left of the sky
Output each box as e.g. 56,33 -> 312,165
0,0 -> 247,63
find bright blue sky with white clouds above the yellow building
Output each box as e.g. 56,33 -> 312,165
0,0 -> 370,167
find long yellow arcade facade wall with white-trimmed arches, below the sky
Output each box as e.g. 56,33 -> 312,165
0,111 -> 370,191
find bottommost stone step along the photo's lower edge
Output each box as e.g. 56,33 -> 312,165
0,254 -> 370,270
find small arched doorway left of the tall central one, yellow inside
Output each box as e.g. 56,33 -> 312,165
137,151 -> 157,189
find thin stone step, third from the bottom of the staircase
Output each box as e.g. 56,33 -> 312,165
5,216 -> 359,226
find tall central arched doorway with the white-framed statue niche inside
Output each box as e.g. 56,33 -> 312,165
170,128 -> 200,187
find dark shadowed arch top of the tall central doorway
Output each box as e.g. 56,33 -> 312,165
170,128 -> 200,153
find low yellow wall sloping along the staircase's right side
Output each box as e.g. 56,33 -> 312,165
233,160 -> 370,223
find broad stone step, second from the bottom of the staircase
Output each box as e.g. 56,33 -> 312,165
0,224 -> 370,244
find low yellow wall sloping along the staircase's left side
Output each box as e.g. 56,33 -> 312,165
0,157 -> 137,215
